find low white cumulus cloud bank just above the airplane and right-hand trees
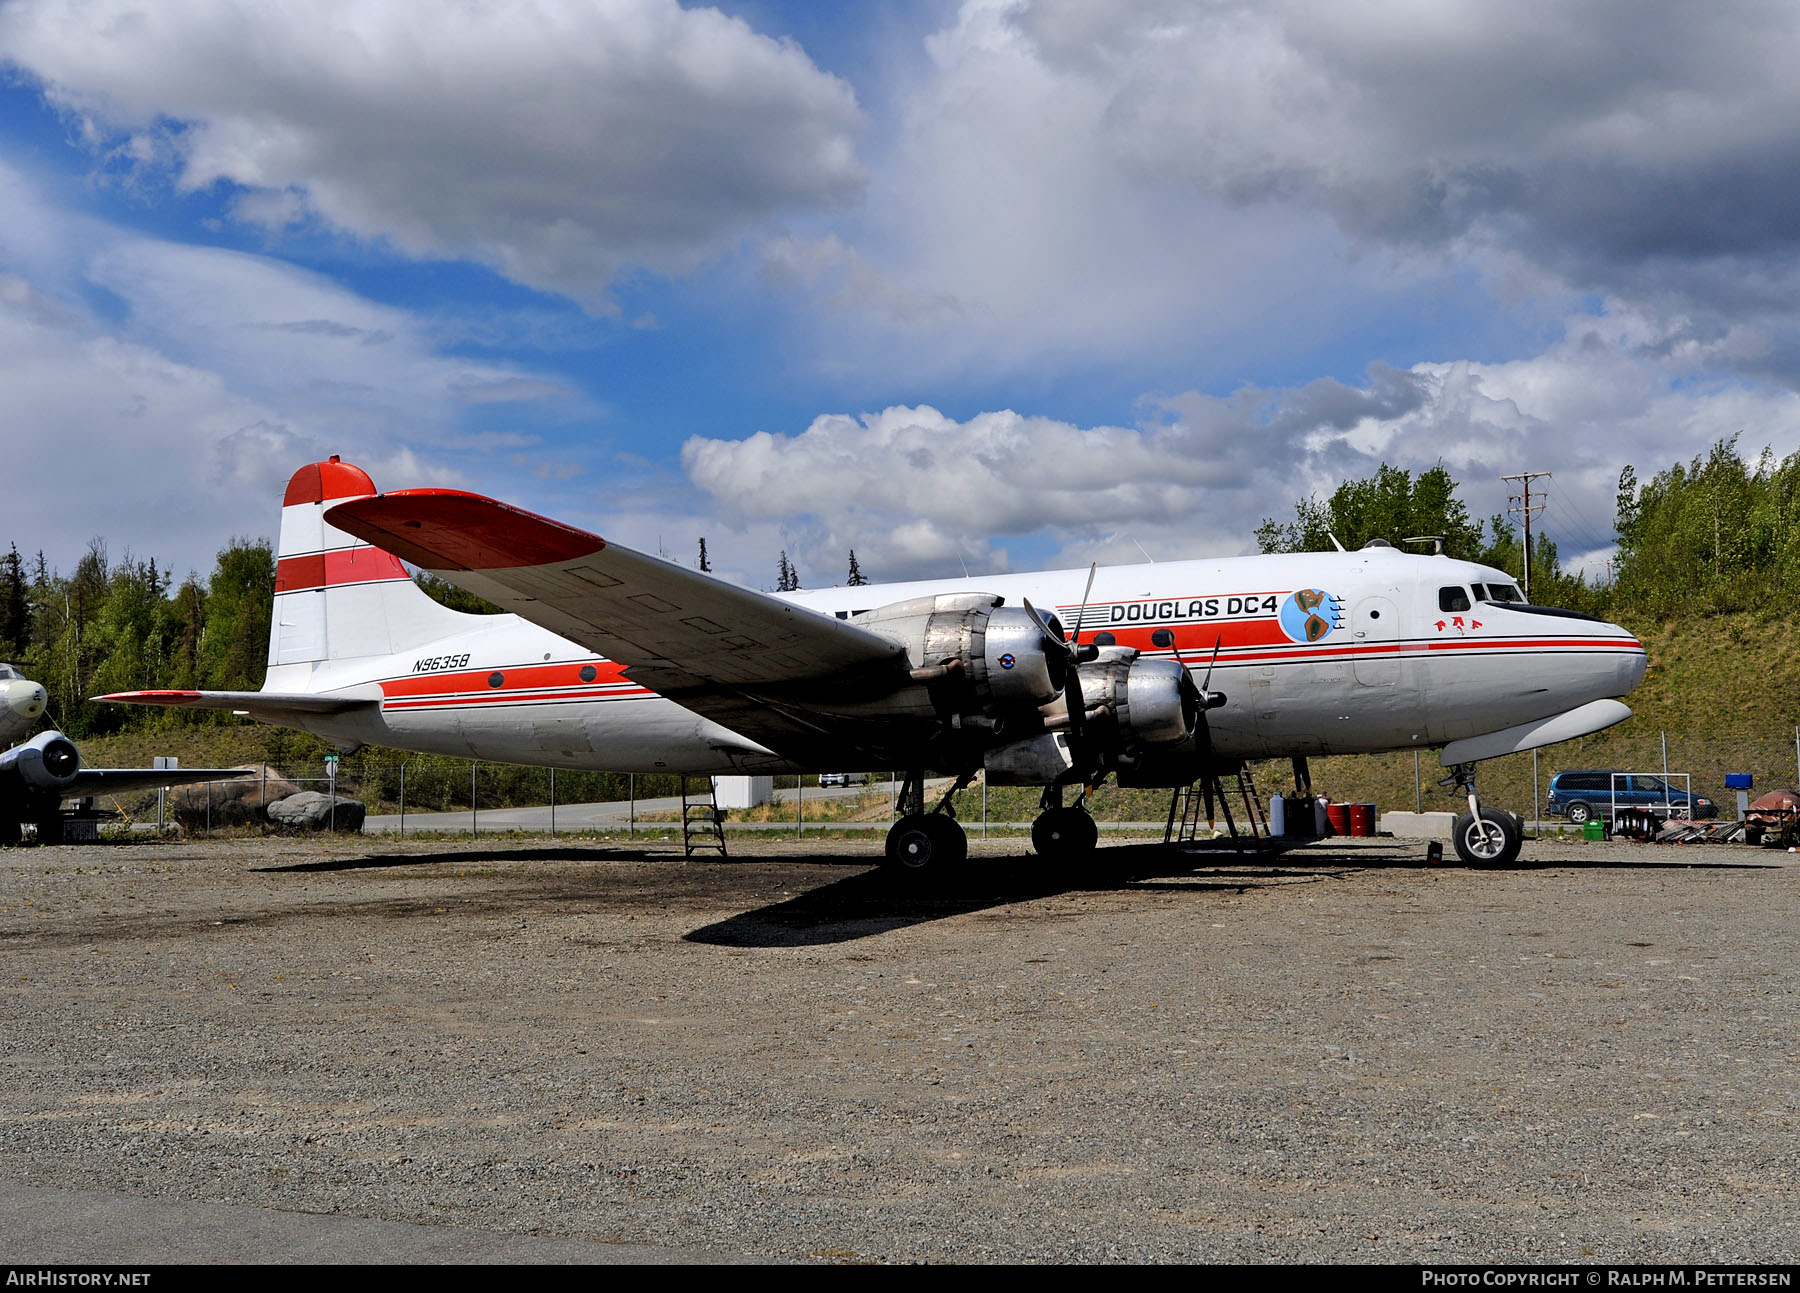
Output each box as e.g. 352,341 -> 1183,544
682,308 -> 1800,578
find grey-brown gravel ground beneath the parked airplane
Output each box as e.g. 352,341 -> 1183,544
0,839 -> 1800,1262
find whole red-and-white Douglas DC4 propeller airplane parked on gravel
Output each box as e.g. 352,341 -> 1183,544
101,457 -> 1645,870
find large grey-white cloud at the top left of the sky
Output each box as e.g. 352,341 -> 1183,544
0,0 -> 862,308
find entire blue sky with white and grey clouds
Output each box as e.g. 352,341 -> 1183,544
0,0 -> 1800,585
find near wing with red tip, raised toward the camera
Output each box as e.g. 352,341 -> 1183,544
326,490 -> 911,762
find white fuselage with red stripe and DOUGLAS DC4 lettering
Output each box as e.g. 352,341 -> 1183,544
270,547 -> 1643,773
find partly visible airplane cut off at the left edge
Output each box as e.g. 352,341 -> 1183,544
0,665 -> 245,845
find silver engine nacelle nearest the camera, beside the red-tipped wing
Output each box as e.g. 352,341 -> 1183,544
857,592 -> 1069,719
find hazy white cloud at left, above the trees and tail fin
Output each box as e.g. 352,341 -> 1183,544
0,164 -> 578,574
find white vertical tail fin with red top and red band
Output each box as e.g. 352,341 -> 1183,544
263,456 -> 479,692
